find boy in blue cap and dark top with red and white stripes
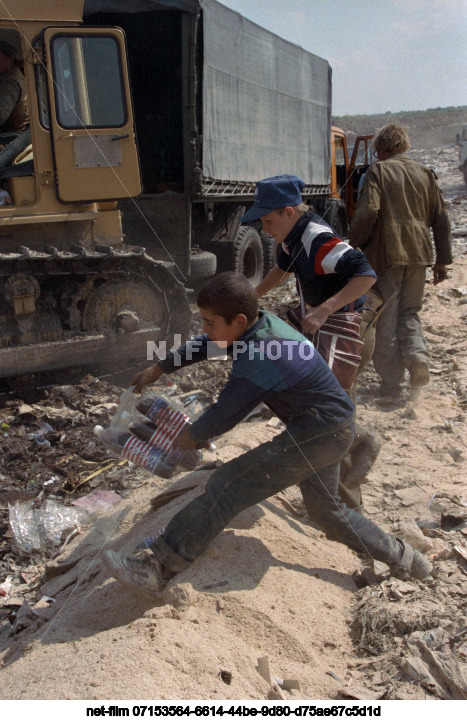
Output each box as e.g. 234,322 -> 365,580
250,175 -> 380,513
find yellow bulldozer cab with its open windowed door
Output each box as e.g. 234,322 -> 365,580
0,13 -> 141,212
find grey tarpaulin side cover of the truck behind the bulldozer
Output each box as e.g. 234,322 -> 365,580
201,0 -> 331,184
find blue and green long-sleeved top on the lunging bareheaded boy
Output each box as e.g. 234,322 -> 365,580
159,311 -> 354,442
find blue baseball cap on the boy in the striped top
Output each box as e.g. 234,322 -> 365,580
241,175 -> 306,223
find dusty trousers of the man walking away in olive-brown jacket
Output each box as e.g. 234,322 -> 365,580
373,265 -> 429,390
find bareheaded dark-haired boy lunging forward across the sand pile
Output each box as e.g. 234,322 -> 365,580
104,272 -> 432,595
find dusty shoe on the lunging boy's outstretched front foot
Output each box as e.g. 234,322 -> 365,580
102,550 -> 167,596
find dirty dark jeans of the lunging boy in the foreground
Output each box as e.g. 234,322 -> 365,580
150,422 -> 402,573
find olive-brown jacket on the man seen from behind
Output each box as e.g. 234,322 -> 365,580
350,153 -> 452,273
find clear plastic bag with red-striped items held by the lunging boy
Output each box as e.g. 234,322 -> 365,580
94,388 -> 202,478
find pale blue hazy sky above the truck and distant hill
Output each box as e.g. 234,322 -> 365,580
220,0 -> 467,115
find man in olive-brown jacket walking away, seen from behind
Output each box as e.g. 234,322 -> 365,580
350,123 -> 452,397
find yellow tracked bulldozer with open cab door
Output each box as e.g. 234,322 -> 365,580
0,0 -> 190,387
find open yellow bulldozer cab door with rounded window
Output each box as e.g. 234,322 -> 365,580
43,28 -> 141,203
